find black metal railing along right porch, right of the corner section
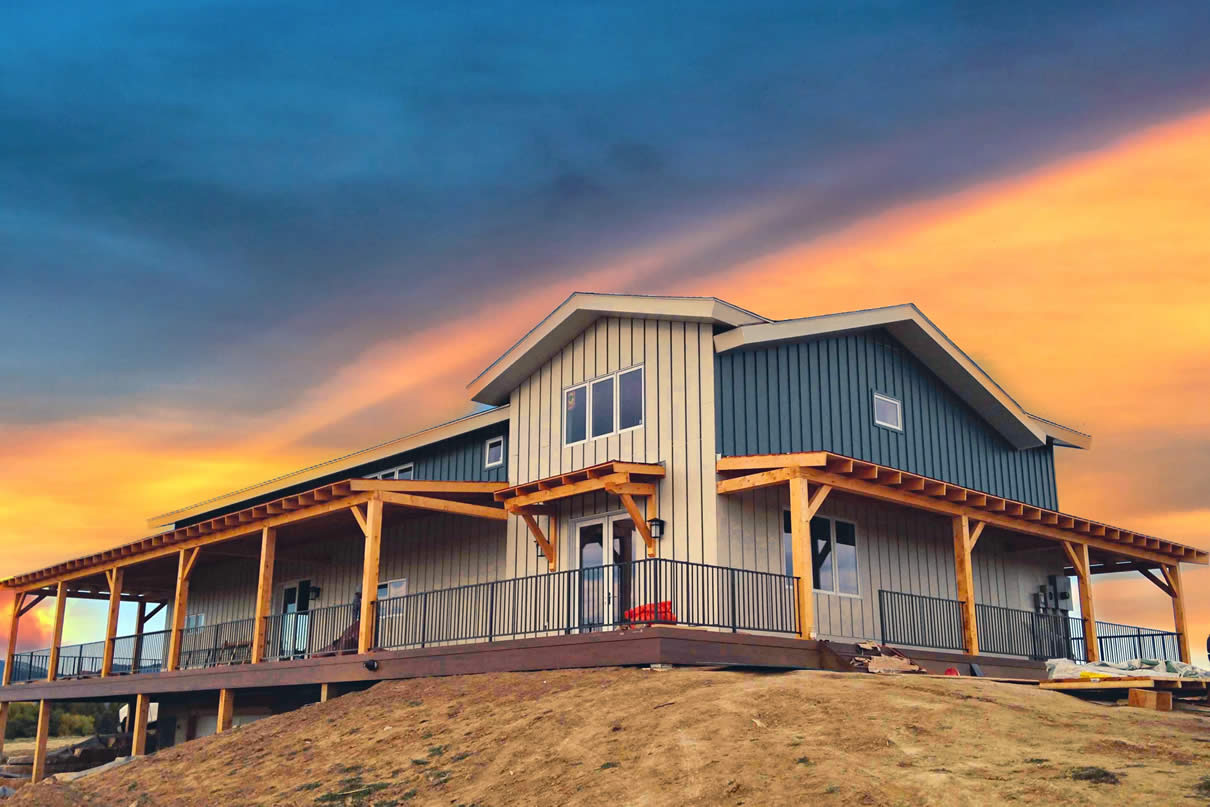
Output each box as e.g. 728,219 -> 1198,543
878,590 -> 1180,663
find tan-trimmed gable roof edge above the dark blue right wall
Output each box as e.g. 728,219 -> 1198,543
714,302 -> 1093,449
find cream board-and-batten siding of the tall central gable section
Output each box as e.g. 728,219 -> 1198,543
506,317 -> 718,577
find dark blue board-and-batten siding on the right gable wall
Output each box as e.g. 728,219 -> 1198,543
716,330 -> 1059,509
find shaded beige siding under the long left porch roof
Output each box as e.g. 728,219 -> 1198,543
182,514 -> 505,624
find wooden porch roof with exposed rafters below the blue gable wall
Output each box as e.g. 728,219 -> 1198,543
716,451 -> 1210,565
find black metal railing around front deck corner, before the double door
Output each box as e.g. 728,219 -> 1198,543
374,558 -> 799,649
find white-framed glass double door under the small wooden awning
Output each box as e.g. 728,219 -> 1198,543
576,513 -> 634,630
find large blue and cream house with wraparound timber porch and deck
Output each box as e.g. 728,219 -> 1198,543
0,294 -> 1208,779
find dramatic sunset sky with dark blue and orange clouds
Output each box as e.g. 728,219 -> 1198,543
0,0 -> 1210,662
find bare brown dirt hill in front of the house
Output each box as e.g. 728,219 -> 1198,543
10,669 -> 1210,807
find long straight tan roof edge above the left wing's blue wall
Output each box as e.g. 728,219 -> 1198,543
148,407 -> 508,529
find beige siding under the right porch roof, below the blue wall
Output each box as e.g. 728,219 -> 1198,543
719,485 -> 1064,641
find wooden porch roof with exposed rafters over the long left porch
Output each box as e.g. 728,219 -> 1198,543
0,479 -> 507,592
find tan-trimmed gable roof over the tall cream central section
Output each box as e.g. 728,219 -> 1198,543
467,292 -> 768,405
